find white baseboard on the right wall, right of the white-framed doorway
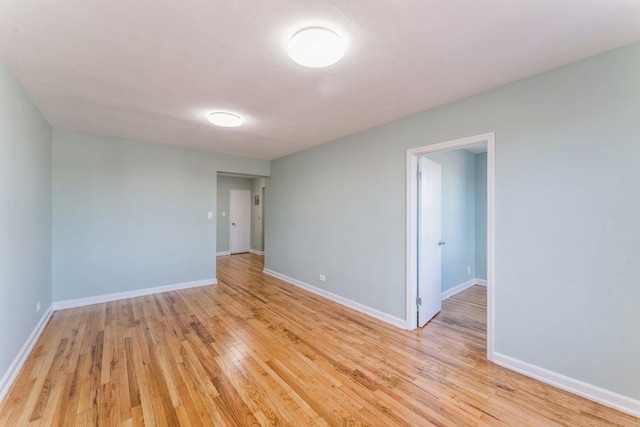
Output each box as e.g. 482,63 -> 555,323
493,353 -> 640,417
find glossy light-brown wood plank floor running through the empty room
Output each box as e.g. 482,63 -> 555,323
0,254 -> 640,426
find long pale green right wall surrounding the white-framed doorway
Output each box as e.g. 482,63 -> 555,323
265,44 -> 640,399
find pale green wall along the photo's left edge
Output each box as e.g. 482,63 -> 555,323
0,59 -> 51,388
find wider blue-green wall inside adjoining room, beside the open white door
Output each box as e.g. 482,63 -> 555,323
425,150 -> 476,292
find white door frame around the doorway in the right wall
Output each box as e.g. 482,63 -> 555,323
406,132 -> 495,360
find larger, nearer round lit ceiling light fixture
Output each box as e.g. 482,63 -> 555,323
289,27 -> 345,68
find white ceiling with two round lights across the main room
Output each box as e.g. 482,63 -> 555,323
0,0 -> 640,159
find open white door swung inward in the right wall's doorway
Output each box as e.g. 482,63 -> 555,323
418,157 -> 444,327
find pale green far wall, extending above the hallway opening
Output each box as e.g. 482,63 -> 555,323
53,130 -> 270,301
